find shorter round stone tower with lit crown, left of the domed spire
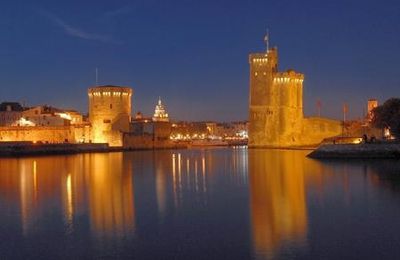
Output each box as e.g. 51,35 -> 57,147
88,85 -> 133,146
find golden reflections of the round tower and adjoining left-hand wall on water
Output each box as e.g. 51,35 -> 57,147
0,153 -> 135,239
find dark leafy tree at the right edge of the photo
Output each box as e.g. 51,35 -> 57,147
372,98 -> 400,139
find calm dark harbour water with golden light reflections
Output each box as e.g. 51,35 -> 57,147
0,148 -> 400,259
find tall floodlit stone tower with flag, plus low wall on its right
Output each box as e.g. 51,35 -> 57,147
249,48 -> 341,148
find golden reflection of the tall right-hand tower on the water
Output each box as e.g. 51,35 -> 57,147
248,150 -> 319,257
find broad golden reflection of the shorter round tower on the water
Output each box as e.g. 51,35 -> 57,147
84,153 -> 134,241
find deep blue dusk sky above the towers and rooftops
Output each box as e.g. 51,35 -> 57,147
0,0 -> 400,120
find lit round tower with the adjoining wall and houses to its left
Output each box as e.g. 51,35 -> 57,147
0,85 -> 132,146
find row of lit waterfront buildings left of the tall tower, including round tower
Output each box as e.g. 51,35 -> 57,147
0,85 -> 247,149
